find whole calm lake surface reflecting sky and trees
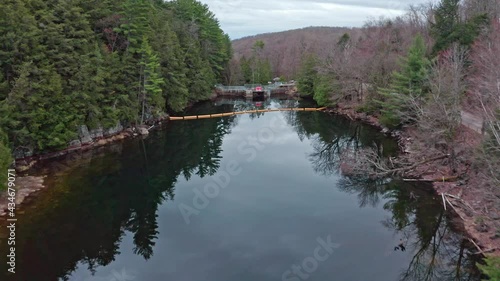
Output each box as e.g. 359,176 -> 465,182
0,99 -> 478,281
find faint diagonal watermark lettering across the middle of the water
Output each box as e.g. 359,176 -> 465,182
178,112 -> 287,224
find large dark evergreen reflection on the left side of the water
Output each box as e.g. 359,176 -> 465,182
0,106 -> 236,281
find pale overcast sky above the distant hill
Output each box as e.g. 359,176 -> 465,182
200,0 -> 429,39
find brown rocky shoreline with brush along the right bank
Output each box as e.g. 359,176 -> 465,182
327,105 -> 500,256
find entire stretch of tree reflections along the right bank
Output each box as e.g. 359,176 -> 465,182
286,109 -> 478,281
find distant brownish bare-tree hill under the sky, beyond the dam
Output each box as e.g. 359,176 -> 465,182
232,27 -> 357,77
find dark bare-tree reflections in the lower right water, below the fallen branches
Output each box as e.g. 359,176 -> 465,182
339,178 -> 479,281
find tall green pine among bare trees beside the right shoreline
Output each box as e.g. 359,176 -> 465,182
377,35 -> 430,127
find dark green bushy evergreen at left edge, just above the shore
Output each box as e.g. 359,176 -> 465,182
0,63 -> 76,151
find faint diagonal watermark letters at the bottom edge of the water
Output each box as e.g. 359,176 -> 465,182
281,235 -> 340,281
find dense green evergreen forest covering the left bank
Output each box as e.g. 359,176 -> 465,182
0,0 -> 232,158
